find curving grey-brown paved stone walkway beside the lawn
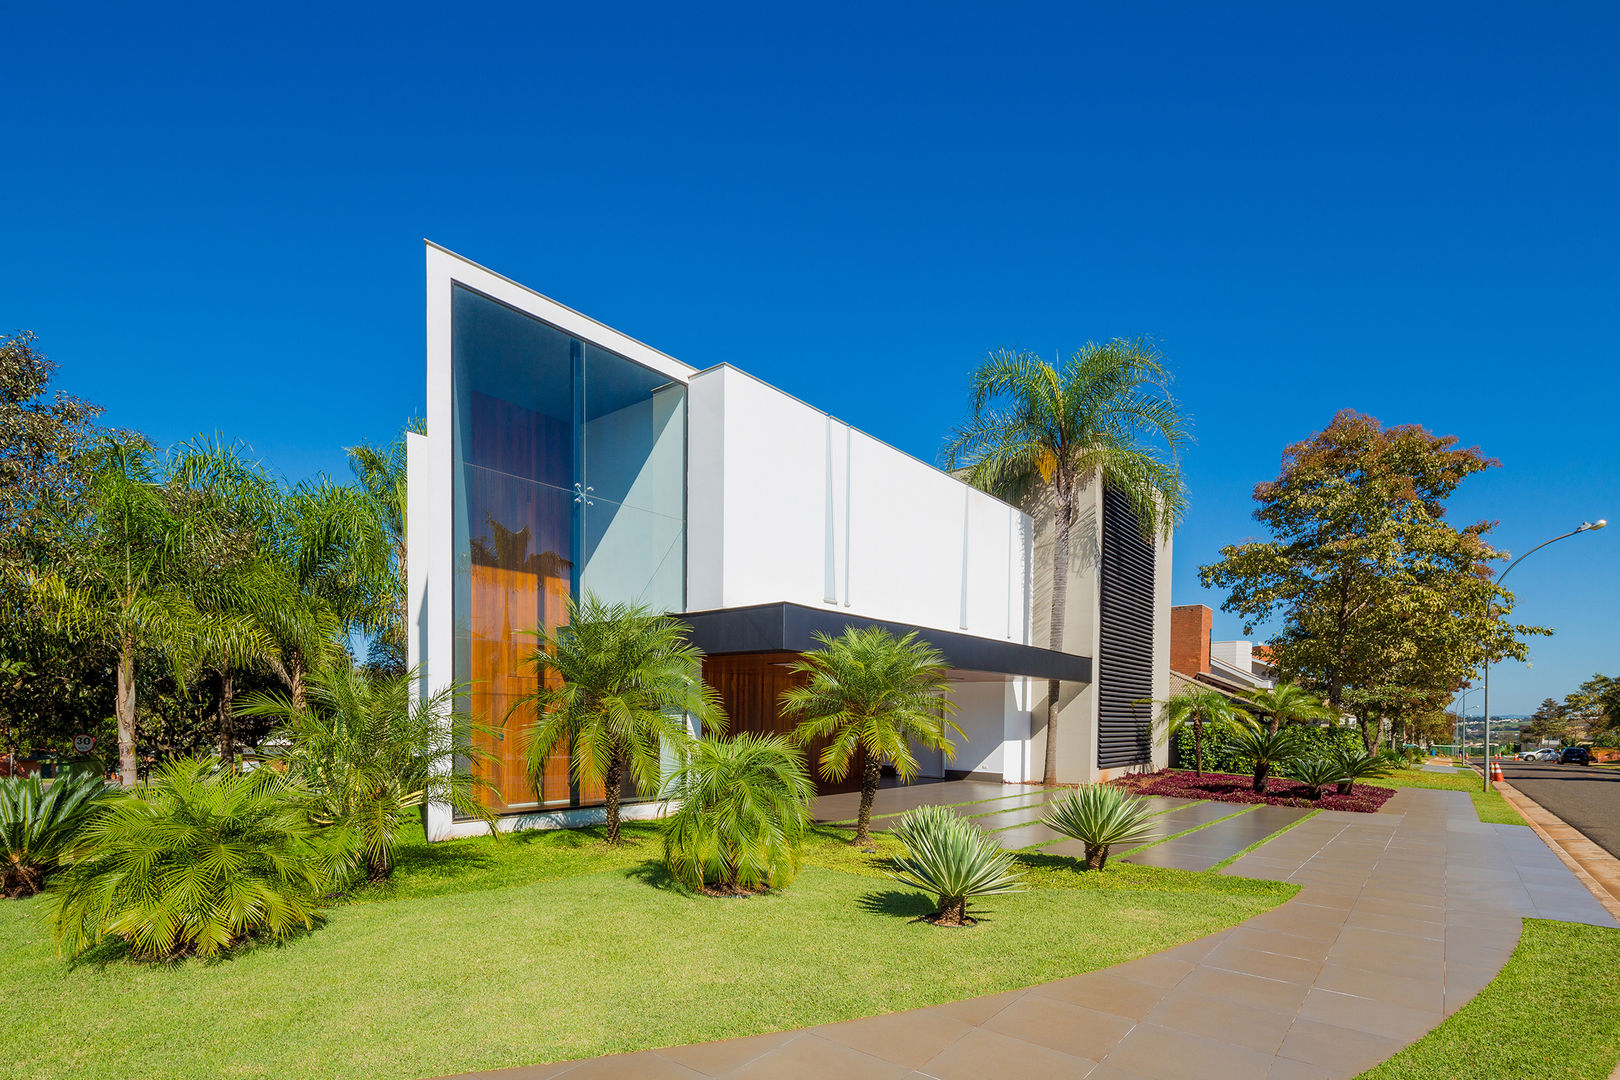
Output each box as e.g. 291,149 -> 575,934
450,789 -> 1615,1080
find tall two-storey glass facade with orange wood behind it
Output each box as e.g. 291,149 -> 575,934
450,285 -> 687,813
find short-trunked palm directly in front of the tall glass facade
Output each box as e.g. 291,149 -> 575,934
507,593 -> 726,844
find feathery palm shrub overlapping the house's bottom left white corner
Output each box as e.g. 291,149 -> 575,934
241,664 -> 494,881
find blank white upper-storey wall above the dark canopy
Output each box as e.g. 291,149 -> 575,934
687,366 -> 1030,643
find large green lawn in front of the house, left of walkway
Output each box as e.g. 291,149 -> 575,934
0,826 -> 1294,1080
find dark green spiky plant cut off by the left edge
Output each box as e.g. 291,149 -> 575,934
0,772 -> 107,897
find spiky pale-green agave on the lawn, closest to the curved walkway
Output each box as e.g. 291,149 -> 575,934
889,806 -> 1024,926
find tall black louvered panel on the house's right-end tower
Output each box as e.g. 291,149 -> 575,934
1097,487 -> 1153,769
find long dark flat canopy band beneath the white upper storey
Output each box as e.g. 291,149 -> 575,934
677,602 -> 1092,683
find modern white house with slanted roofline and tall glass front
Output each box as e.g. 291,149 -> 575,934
407,243 -> 1170,839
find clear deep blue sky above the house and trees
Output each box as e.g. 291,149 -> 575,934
0,3 -> 1620,712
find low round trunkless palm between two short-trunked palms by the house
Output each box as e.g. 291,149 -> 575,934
664,733 -> 813,895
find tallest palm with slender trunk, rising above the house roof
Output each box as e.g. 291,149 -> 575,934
943,338 -> 1189,787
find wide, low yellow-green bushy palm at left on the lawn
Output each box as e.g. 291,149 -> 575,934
47,758 -> 339,960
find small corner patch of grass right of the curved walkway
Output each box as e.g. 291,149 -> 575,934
1361,918 -> 1620,1080
